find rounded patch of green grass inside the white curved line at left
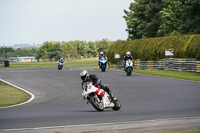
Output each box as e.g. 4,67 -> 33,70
0,81 -> 30,107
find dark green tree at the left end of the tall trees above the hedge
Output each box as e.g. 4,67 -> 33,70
124,0 -> 162,40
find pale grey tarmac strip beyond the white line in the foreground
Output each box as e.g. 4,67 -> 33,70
0,117 -> 200,133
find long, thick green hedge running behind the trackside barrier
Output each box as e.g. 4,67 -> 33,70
107,34 -> 200,63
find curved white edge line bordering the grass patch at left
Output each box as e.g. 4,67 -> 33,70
0,79 -> 35,109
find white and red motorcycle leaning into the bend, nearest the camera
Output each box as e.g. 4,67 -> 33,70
82,82 -> 121,111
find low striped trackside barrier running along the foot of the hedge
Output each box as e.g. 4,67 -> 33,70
109,58 -> 200,72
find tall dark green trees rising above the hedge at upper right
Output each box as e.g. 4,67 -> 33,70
123,0 -> 200,40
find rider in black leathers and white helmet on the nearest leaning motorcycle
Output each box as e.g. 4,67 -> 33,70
80,70 -> 116,100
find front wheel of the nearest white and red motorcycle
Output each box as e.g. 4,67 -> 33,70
90,94 -> 104,111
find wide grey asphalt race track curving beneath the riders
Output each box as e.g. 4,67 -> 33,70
0,67 -> 200,129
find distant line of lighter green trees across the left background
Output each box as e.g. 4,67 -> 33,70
0,39 -> 113,60
